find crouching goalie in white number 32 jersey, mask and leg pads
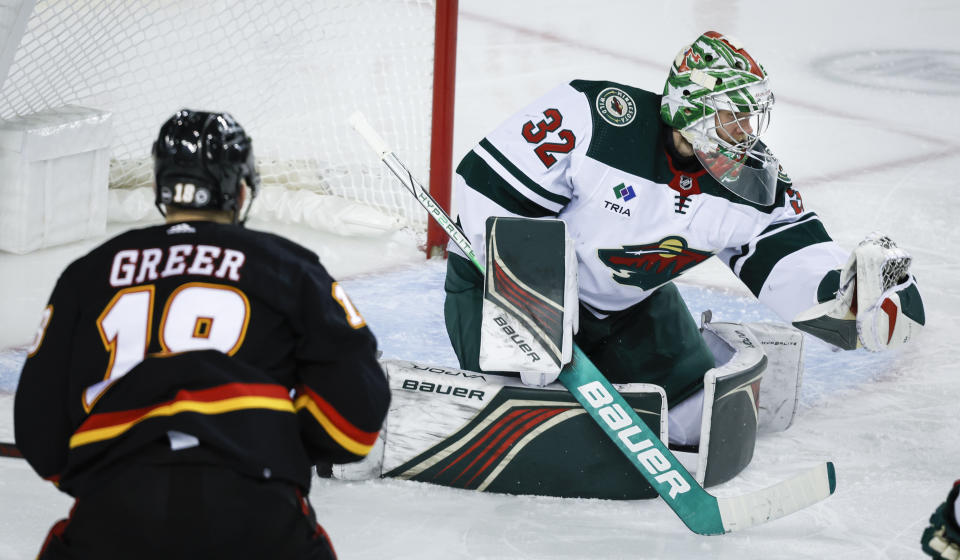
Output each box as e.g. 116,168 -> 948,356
342,32 -> 925,498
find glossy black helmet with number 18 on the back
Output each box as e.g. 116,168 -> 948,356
153,109 -> 260,223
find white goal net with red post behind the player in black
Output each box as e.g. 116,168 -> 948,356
0,0 -> 458,255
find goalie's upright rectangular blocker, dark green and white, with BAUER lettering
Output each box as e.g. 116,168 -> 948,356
480,218 -> 579,387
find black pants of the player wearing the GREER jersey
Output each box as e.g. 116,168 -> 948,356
39,464 -> 336,559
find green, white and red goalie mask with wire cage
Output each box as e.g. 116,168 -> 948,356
660,31 -> 779,206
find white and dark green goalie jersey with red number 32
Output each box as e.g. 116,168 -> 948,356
449,80 -> 847,321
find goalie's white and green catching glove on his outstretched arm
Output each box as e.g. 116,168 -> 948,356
793,233 -> 925,352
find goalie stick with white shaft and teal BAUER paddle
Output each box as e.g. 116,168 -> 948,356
350,112 -> 836,535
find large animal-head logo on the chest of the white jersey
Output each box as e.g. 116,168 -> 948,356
597,235 -> 713,290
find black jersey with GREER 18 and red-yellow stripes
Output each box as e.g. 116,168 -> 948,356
14,222 -> 390,495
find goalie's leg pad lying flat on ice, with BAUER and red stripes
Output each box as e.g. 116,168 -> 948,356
352,360 -> 667,499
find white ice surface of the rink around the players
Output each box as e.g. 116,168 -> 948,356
0,0 -> 960,559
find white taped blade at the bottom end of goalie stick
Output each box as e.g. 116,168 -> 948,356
717,462 -> 837,532
